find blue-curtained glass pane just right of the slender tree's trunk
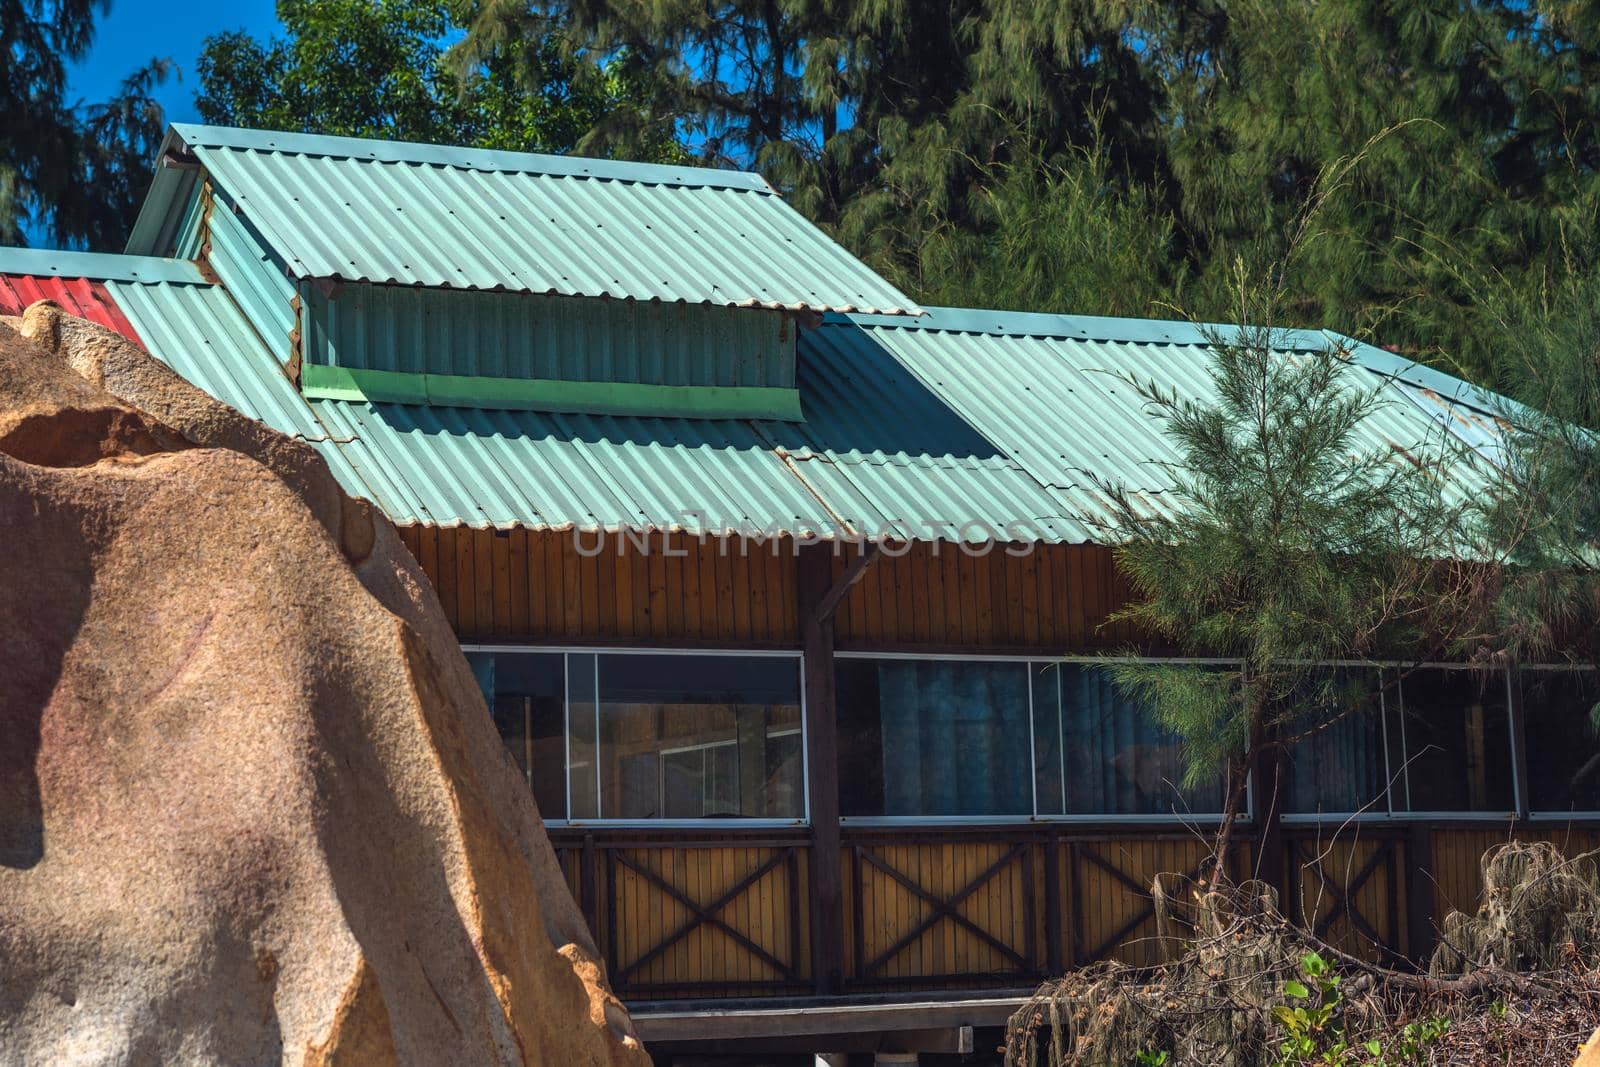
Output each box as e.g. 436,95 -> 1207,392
1280,667 -> 1389,814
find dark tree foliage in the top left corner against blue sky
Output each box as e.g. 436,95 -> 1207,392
0,0 -> 170,248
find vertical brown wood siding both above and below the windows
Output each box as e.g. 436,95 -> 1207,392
400,526 -> 1600,1000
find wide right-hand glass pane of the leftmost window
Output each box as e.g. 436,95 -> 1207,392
598,654 -> 805,819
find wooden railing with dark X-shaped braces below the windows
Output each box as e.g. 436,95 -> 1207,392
550,824 -> 1600,1000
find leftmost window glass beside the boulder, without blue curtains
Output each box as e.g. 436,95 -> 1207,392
469,651 -> 805,821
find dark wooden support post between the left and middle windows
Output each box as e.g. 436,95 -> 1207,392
795,544 -> 845,995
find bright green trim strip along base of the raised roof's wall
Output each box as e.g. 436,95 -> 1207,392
301,363 -> 802,422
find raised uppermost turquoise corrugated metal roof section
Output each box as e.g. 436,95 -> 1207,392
130,125 -> 920,315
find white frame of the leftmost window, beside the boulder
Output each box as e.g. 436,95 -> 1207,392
461,641 -> 811,830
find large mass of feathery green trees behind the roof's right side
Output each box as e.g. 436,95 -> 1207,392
461,0 -> 1600,391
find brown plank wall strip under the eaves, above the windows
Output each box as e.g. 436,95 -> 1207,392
400,526 -> 1131,654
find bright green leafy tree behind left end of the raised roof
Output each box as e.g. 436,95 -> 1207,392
197,0 -> 677,158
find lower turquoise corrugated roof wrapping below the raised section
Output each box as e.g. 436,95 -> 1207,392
0,246 -> 1502,542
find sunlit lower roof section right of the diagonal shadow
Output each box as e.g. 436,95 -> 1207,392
832,309 -> 1493,515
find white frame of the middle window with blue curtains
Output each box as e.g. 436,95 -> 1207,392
834,649 -> 1254,829
